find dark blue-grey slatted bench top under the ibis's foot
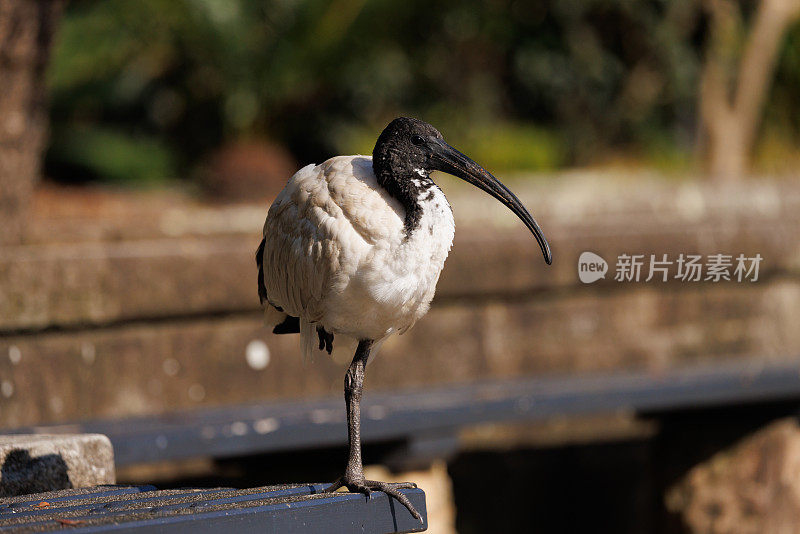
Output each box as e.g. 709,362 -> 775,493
0,484 -> 427,534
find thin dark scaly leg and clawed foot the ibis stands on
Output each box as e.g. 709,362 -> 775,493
325,340 -> 422,521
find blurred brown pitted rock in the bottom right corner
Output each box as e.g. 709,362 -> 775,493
666,418 -> 800,534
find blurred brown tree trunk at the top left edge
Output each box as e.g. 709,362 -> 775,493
0,0 -> 62,244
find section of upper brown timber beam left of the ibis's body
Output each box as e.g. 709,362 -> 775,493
0,236 -> 259,330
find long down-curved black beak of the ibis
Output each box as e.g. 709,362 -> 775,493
431,139 -> 553,265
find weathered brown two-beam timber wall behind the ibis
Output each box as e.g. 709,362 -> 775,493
0,180 -> 800,427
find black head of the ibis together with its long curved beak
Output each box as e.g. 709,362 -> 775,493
372,117 -> 553,265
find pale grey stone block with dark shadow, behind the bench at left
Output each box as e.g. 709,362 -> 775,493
0,434 -> 115,497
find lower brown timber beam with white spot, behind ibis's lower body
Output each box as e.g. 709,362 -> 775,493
0,279 -> 800,427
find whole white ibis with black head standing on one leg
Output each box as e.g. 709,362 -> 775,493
256,117 -> 552,519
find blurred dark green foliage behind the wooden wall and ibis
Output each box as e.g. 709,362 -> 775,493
47,0 -> 800,181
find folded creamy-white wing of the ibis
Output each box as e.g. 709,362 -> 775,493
263,156 -> 402,323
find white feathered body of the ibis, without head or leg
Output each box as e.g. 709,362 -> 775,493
263,156 -> 455,362
